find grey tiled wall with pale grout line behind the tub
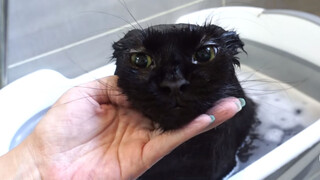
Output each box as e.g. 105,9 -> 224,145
0,0 -> 320,87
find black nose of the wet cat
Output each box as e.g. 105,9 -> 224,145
160,79 -> 189,94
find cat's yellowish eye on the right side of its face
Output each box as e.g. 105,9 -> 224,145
192,46 -> 217,64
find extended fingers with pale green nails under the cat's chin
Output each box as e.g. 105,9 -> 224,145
143,97 -> 242,169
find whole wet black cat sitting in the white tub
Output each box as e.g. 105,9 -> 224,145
113,24 -> 255,180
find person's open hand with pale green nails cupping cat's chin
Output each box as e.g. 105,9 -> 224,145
0,76 -> 241,179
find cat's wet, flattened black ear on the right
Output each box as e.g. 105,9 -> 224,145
221,31 -> 247,66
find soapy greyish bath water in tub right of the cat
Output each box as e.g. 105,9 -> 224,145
230,65 -> 320,175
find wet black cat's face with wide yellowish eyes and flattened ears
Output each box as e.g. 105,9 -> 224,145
113,24 -> 243,130
